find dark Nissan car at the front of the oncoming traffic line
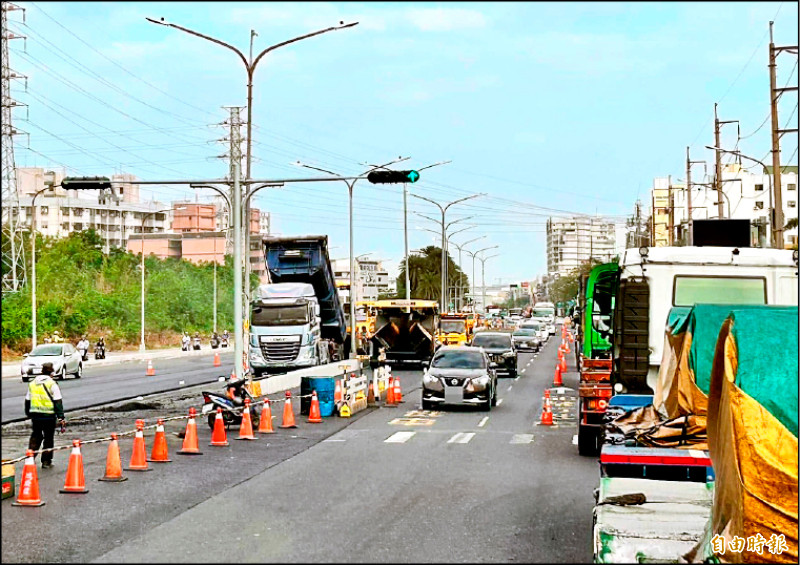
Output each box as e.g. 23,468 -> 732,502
422,345 -> 497,412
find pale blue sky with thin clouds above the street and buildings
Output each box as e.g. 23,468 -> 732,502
8,2 -> 798,284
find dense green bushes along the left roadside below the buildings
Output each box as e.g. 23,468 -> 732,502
2,230 -> 253,357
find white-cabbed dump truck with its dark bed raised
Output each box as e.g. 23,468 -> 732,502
249,235 -> 347,376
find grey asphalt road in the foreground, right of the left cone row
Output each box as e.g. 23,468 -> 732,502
2,339 -> 598,563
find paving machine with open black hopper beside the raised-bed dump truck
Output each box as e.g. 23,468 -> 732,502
370,299 -> 439,365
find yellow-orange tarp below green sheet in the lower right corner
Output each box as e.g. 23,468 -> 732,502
708,318 -> 798,563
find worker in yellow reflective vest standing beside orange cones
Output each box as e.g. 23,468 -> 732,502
25,362 -> 65,469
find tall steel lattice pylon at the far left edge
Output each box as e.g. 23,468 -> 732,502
1,2 -> 26,296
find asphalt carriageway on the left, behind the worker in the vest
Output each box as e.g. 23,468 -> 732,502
0,350 -> 233,424
